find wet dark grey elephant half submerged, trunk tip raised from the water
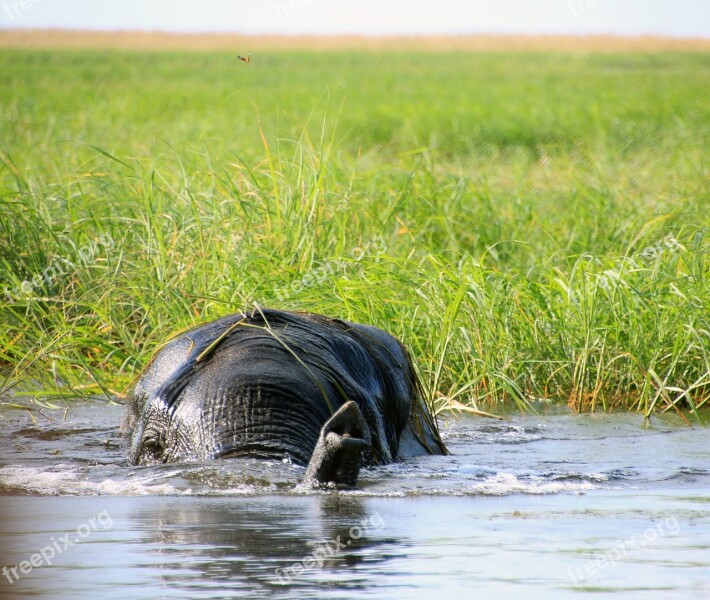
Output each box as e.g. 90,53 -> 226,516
124,309 -> 447,486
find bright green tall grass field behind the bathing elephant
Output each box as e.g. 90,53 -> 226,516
0,50 -> 710,414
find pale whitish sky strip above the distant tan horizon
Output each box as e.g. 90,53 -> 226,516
0,0 -> 710,38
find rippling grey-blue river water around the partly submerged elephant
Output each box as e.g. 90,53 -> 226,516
0,403 -> 710,600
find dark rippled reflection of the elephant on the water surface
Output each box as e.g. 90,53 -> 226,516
129,493 -> 402,595
